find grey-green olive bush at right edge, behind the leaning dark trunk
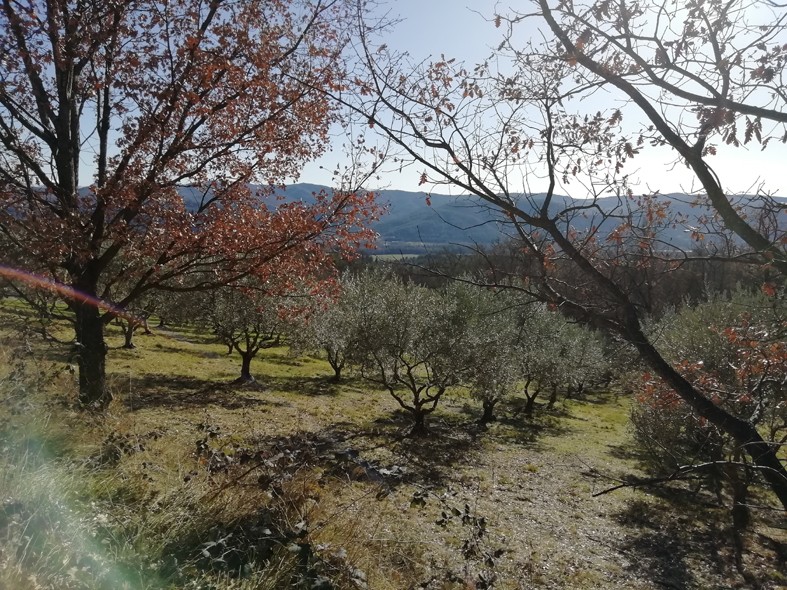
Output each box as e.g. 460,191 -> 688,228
632,290 -> 787,504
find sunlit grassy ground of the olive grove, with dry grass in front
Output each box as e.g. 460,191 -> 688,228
0,306 -> 787,590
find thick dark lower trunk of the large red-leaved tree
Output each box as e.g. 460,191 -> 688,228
74,302 -> 112,409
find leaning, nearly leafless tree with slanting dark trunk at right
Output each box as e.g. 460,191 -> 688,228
344,0 -> 787,509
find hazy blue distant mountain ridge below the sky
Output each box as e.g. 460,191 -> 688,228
182,183 -> 787,254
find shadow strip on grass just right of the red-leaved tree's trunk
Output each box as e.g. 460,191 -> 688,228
121,373 -> 284,410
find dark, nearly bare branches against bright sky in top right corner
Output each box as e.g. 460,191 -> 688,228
528,0 -> 787,274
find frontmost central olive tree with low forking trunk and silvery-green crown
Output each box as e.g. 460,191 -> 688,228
342,272 -> 467,436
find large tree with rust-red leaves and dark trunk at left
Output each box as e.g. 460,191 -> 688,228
0,0 -> 382,407
